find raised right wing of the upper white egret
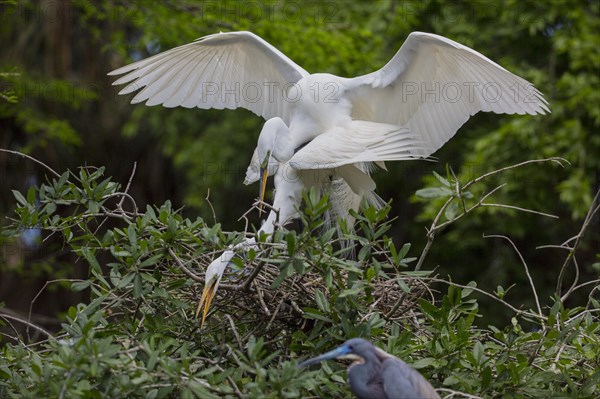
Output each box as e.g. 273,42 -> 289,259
347,32 -> 549,155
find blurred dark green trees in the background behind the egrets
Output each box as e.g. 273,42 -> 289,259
0,0 -> 600,338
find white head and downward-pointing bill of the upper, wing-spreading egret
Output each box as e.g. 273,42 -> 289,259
256,117 -> 294,214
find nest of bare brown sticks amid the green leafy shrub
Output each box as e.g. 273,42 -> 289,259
178,243 -> 433,338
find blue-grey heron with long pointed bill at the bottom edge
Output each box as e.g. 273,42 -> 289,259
299,338 -> 440,399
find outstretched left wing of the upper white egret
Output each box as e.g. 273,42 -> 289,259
109,32 -> 308,122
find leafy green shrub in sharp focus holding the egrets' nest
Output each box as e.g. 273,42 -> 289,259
0,167 -> 600,398
